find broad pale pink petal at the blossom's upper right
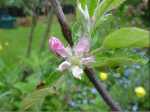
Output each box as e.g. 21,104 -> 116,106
74,37 -> 90,54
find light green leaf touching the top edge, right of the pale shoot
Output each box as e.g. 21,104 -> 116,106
95,0 -> 125,19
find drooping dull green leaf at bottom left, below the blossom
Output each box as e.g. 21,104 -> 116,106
21,76 -> 64,111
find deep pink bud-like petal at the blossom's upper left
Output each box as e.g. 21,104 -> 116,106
49,37 -> 67,57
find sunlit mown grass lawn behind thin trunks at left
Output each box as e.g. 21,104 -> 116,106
0,20 -> 61,64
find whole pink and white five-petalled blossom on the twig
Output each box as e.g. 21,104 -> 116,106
49,37 -> 94,79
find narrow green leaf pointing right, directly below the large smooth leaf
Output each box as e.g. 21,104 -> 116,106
93,49 -> 148,67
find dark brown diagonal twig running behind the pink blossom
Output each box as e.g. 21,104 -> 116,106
50,0 -> 121,111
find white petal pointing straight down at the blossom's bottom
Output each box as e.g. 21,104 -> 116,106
71,66 -> 83,79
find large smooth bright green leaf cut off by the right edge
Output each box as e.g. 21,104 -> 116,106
102,27 -> 150,48
